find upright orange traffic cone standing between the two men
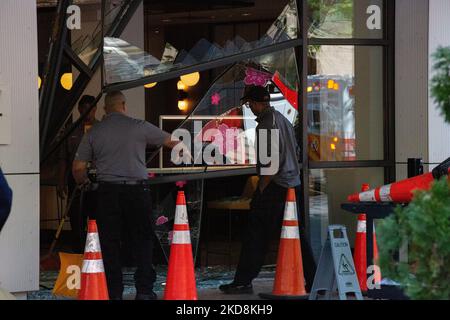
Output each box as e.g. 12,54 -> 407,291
164,191 -> 197,300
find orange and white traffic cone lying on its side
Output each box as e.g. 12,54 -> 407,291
348,173 -> 442,203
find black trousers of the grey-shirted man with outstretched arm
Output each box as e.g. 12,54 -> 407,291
96,183 -> 156,299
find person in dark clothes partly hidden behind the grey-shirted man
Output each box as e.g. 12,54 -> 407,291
57,95 -> 98,253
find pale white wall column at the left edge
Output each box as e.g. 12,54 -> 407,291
0,0 -> 39,297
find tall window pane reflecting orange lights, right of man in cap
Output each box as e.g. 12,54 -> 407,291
307,46 -> 384,161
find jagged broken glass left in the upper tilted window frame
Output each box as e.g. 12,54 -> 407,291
104,0 -> 299,84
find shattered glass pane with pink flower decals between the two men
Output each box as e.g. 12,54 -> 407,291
156,49 -> 299,168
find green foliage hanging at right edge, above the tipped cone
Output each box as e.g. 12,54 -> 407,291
431,47 -> 450,123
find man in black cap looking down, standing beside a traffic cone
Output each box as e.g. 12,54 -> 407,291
219,86 -> 315,294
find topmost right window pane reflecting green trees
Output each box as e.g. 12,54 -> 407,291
308,0 -> 384,39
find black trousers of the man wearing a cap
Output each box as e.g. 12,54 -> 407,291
234,182 -> 316,291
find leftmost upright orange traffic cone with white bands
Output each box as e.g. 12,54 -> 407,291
78,220 -> 109,300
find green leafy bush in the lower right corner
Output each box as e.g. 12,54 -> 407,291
377,177 -> 450,299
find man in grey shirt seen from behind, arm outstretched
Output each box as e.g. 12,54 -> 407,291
72,91 -> 179,300
